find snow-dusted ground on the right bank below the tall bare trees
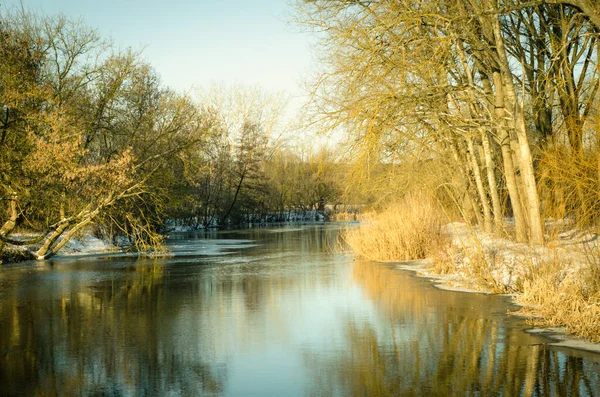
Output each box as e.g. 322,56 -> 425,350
397,222 -> 600,353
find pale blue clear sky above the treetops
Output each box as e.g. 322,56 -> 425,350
0,0 -> 311,96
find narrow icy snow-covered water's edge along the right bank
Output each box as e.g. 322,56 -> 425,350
392,259 -> 600,358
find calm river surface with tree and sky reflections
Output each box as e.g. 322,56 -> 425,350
0,225 -> 600,396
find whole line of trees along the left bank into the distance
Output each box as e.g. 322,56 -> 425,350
0,9 -> 352,260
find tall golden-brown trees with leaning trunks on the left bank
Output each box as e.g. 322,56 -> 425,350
0,12 -> 214,259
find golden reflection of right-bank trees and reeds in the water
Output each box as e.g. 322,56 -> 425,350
305,261 -> 600,397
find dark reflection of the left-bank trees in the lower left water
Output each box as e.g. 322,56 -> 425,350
0,259 -> 226,396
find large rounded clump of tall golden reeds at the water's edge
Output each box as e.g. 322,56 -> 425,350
343,195 -> 449,261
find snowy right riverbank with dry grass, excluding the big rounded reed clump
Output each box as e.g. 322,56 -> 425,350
390,223 -> 600,353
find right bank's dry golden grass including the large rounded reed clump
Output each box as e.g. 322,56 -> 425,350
344,203 -> 600,342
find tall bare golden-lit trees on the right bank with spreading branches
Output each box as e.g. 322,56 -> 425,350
298,0 -> 599,244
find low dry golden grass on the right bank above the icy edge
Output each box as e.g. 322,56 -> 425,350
436,226 -> 600,342
